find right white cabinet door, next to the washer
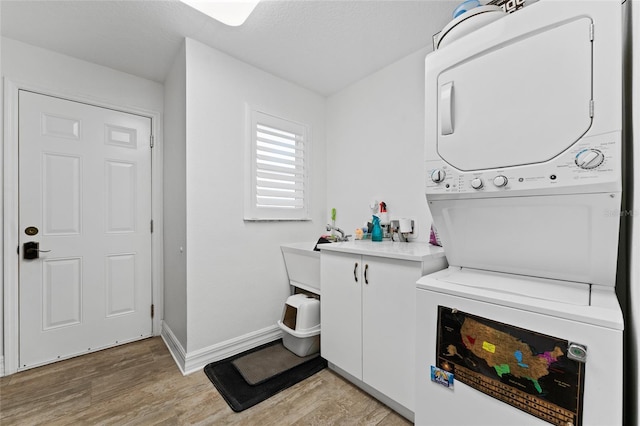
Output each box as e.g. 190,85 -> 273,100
362,256 -> 422,411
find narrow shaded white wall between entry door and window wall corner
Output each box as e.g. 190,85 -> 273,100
163,42 -> 187,348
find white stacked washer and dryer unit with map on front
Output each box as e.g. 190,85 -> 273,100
415,0 -> 624,426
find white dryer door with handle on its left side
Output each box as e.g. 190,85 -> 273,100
438,17 -> 592,171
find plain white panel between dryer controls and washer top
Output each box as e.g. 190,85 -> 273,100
429,193 -> 620,287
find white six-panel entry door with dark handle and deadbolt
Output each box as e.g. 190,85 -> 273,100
19,90 -> 152,368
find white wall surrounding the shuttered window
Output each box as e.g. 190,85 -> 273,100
182,39 -> 326,353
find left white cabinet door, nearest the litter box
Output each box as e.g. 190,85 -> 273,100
320,252 -> 362,379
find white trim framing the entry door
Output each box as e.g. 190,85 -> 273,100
0,78 -> 164,376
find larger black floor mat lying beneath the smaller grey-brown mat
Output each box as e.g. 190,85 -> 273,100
204,340 -> 327,412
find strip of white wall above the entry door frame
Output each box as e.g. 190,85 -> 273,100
0,38 -> 163,373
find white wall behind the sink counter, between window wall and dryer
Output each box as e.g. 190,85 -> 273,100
327,50 -> 431,241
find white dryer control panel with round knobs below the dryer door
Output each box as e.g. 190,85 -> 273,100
426,132 -> 621,198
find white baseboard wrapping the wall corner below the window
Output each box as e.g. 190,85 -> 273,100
161,322 -> 282,375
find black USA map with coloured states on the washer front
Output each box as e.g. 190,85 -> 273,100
438,306 -> 586,426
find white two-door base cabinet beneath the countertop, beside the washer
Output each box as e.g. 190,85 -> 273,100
320,250 -> 446,411
